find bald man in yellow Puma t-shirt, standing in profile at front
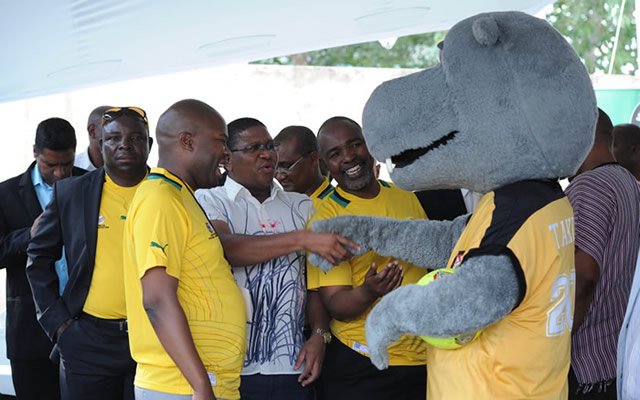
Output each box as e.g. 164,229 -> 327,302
125,100 -> 246,400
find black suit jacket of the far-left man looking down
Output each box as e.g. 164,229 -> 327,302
0,162 -> 85,360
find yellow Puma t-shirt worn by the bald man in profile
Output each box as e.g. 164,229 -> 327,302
124,168 -> 246,399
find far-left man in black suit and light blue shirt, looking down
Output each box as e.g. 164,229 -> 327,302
0,118 -> 84,400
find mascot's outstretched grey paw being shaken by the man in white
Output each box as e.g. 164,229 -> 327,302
309,215 -> 371,272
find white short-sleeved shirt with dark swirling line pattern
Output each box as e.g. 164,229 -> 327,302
196,177 -> 314,375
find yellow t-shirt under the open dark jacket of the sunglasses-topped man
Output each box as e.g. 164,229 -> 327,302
82,173 -> 146,319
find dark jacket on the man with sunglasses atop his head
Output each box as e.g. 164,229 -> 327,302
27,168 -> 104,340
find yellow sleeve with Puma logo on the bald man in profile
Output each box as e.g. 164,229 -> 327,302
131,189 -> 189,279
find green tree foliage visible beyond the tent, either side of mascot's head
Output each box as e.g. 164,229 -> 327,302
256,0 -> 637,74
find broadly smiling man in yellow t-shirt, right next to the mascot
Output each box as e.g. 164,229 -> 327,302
308,117 -> 426,400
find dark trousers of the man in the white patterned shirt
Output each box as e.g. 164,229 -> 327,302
240,374 -> 313,400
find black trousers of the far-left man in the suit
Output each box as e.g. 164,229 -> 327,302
10,358 -> 60,400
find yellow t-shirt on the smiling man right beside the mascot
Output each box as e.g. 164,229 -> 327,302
307,181 -> 427,365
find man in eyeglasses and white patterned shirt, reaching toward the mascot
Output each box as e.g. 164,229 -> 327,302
196,118 -> 356,400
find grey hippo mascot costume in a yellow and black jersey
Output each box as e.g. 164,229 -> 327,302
310,12 -> 597,400
